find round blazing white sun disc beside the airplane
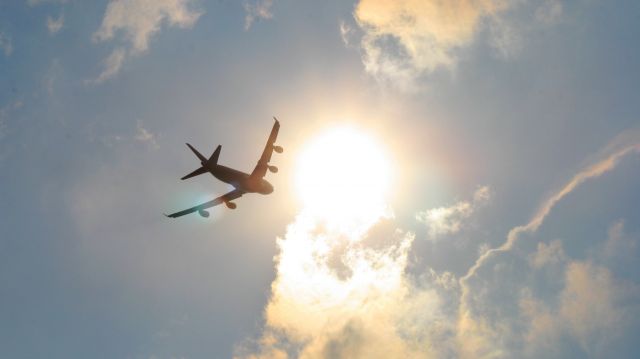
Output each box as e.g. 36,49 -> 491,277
295,127 -> 392,225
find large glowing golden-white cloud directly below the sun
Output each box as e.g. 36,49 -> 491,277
236,212 -> 458,358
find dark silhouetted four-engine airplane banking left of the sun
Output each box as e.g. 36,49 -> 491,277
165,117 -> 283,218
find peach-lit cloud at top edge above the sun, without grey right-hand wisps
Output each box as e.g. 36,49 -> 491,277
354,0 -> 511,85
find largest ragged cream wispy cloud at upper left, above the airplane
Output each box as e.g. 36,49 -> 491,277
91,0 -> 202,83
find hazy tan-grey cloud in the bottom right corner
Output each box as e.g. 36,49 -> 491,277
519,261 -> 640,357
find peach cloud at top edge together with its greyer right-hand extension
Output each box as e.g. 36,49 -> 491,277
354,0 -> 563,91
